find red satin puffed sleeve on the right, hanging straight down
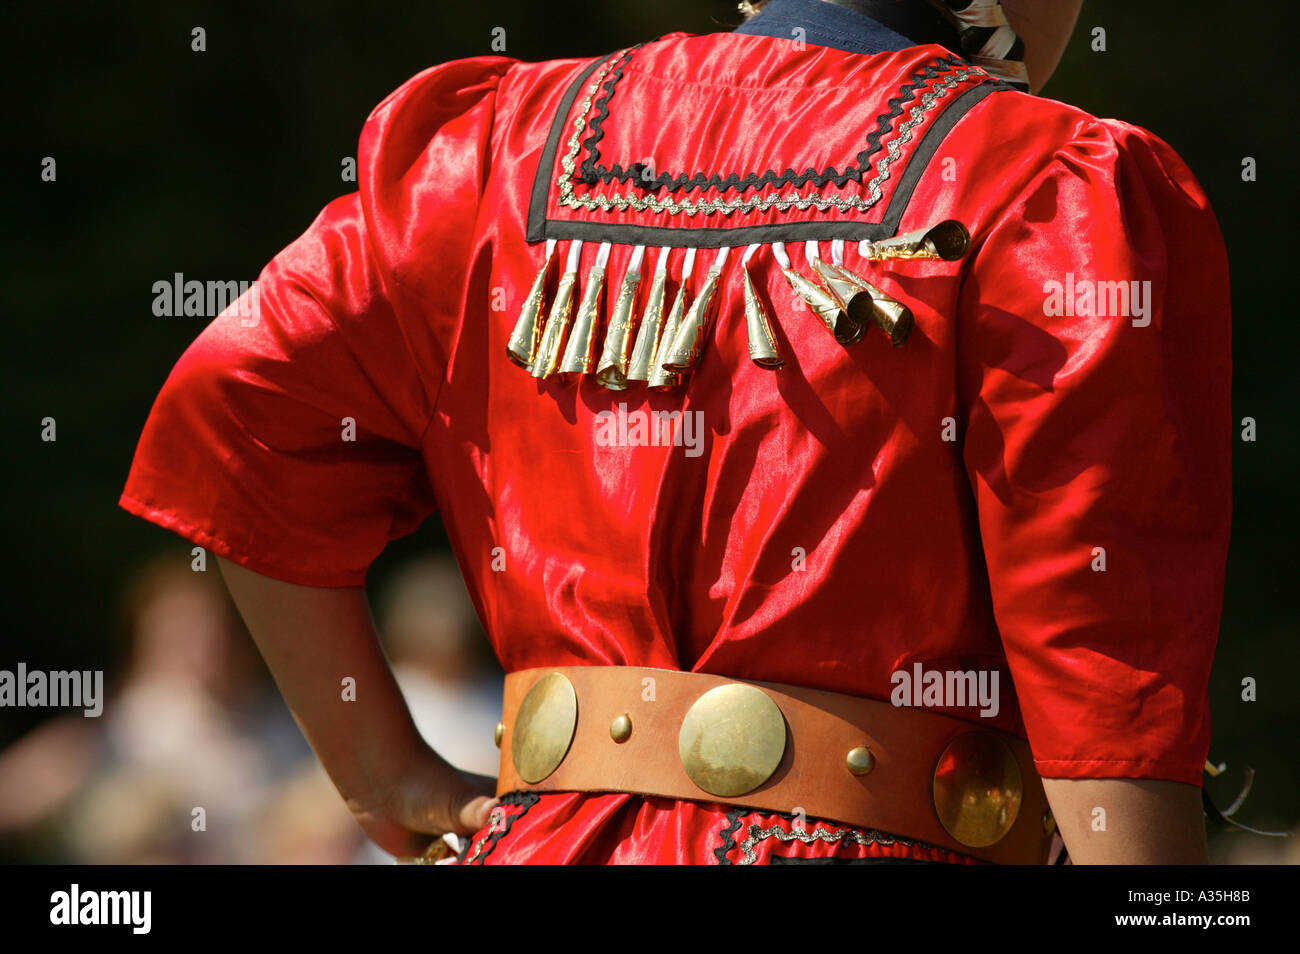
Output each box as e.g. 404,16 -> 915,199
958,118 -> 1232,785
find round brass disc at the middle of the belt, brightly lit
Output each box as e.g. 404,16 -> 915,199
677,682 -> 785,798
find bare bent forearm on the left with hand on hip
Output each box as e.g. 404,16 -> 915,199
218,558 -> 497,855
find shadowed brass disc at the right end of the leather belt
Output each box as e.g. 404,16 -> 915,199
933,730 -> 1024,847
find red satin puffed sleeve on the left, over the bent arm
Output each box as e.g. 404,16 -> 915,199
120,57 -> 511,586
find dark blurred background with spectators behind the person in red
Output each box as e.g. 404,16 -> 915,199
0,0 -> 1300,860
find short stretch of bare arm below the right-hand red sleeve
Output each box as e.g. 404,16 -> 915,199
1043,779 -> 1209,864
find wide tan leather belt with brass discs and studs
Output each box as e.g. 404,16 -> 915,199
497,665 -> 1054,864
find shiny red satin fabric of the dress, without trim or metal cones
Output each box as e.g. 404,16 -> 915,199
121,34 -> 1231,860
